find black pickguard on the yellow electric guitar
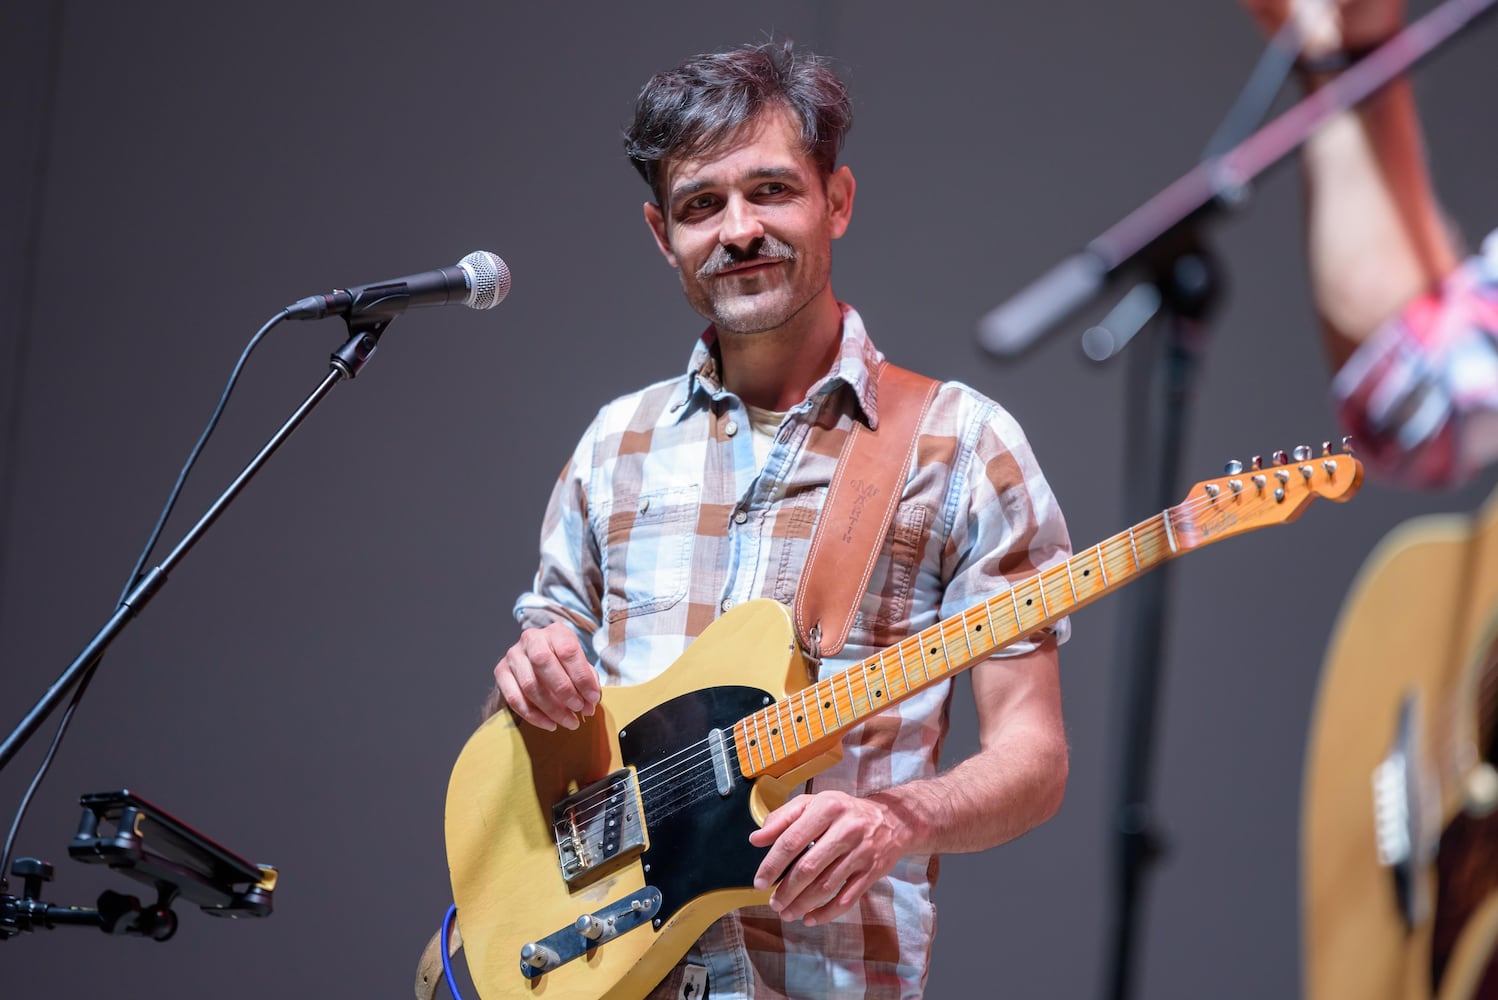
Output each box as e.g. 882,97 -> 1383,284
619,686 -> 774,924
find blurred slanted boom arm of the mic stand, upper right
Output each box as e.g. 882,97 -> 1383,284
978,0 -> 1498,358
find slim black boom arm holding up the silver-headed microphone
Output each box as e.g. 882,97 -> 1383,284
0,314 -> 394,769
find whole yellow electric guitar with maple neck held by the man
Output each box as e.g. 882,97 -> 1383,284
446,448 -> 1363,1000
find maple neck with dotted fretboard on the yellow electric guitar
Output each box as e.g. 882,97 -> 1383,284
734,503 -> 1186,778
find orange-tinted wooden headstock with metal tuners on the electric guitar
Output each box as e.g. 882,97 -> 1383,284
1170,439 -> 1363,548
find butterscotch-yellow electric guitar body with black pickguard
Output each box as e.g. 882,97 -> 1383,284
446,600 -> 837,1000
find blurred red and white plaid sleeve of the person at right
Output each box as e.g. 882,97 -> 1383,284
1332,232 -> 1498,488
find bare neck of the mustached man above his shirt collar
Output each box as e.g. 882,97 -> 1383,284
718,289 -> 842,412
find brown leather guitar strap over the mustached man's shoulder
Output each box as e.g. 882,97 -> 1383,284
795,362 -> 941,662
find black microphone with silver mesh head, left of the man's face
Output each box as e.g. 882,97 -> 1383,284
286,250 -> 509,319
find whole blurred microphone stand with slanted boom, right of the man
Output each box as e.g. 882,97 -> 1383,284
980,0 -> 1498,1000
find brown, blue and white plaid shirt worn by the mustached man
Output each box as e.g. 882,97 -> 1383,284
515,305 -> 1070,1000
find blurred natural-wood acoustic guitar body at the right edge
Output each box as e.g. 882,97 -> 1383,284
1302,479 -> 1498,1000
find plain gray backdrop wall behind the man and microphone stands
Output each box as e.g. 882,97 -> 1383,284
0,0 -> 1498,999
